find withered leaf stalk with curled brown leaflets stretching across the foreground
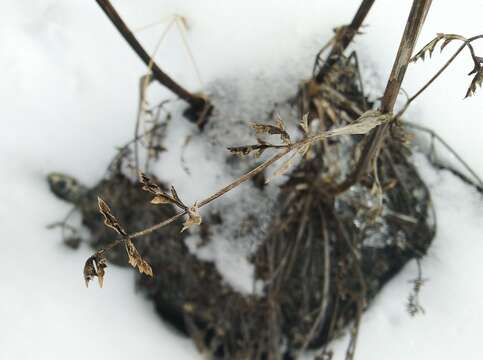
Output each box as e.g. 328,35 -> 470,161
84,110 -> 392,282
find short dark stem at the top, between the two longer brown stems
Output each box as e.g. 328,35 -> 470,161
315,0 -> 375,84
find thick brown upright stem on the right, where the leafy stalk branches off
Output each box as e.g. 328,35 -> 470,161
336,0 -> 432,193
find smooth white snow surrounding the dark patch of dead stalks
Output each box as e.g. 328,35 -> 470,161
0,0 -> 483,360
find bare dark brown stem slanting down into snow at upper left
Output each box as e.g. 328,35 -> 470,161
96,0 -> 211,126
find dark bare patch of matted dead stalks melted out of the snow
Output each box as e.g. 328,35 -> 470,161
51,52 -> 434,359
